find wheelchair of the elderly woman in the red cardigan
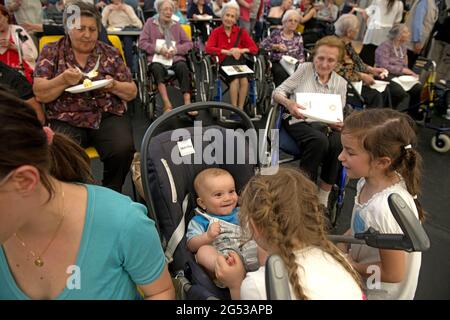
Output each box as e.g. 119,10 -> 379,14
198,55 -> 274,123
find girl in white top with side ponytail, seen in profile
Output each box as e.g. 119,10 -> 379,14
339,109 -> 423,299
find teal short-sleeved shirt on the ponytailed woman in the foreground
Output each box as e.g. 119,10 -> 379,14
0,185 -> 165,300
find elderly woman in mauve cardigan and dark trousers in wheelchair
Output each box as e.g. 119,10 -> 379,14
139,0 -> 193,112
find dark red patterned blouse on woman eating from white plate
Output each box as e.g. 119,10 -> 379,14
34,37 -> 132,129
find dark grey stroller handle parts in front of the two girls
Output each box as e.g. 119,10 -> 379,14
266,193 -> 430,300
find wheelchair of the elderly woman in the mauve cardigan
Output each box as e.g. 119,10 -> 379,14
137,25 -> 199,121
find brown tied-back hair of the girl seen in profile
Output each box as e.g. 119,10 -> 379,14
342,109 -> 425,221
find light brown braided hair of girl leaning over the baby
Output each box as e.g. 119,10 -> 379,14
239,167 -> 361,300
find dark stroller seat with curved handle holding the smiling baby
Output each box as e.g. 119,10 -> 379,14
141,102 -> 259,300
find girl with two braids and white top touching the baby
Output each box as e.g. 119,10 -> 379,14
216,167 -> 364,300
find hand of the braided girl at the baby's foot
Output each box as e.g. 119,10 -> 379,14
215,251 -> 245,290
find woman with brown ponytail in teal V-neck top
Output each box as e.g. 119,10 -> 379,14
0,90 -> 174,300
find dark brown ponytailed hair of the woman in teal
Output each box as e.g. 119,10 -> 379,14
0,87 -> 93,199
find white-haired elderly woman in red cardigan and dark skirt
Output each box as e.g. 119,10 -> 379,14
205,3 -> 258,109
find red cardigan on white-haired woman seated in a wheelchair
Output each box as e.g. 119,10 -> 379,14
205,25 -> 258,62
